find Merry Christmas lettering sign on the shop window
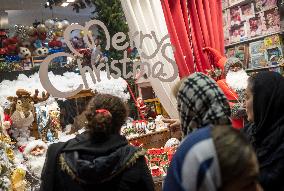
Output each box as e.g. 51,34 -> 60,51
39,20 -> 178,98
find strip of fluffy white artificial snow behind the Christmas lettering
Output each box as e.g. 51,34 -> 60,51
0,71 -> 130,105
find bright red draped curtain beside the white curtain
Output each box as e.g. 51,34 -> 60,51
161,0 -> 224,77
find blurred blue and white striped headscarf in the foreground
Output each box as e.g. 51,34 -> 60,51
163,127 -> 222,191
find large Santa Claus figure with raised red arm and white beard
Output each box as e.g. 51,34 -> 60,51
203,47 -> 249,129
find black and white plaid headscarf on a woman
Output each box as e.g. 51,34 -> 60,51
177,73 -> 231,136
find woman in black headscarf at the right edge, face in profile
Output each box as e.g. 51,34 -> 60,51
246,72 -> 284,191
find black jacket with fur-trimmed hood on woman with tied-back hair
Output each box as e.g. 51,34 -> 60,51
41,134 -> 154,191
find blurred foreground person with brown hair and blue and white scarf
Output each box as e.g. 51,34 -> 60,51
163,125 -> 261,191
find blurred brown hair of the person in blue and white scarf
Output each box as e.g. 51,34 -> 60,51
212,126 -> 256,186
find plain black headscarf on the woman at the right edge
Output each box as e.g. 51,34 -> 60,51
251,72 -> 284,168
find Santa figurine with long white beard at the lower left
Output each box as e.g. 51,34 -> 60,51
23,140 -> 48,191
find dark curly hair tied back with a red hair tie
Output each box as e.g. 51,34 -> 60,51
85,94 -> 128,136
